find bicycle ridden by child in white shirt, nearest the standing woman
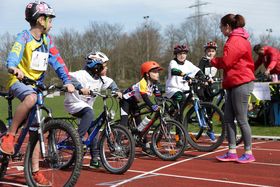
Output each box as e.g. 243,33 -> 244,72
165,78 -> 226,152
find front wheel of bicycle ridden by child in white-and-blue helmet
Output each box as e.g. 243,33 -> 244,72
100,125 -> 135,174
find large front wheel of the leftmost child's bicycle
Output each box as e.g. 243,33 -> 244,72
24,120 -> 82,186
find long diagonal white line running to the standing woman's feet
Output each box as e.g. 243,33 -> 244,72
112,142 -> 266,187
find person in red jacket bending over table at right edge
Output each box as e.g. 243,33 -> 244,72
254,44 -> 280,79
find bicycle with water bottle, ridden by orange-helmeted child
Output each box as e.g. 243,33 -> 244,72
117,98 -> 187,161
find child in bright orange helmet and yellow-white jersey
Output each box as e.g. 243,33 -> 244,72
120,61 -> 163,152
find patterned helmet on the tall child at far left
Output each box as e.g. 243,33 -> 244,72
25,2 -> 55,22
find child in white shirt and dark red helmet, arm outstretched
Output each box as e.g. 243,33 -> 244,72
165,45 -> 215,140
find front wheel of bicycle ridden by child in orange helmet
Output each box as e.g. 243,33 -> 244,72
152,119 -> 186,160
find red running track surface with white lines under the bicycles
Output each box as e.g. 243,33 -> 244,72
0,141 -> 280,187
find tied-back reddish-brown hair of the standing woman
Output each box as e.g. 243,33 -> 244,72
221,14 -> 245,29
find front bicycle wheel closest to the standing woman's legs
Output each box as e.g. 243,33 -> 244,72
184,102 -> 225,152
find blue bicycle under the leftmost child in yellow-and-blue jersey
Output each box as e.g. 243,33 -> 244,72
0,75 -> 82,186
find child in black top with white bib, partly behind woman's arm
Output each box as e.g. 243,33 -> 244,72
198,41 -> 218,78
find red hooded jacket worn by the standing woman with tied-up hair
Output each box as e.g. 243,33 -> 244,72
211,28 -> 255,89
